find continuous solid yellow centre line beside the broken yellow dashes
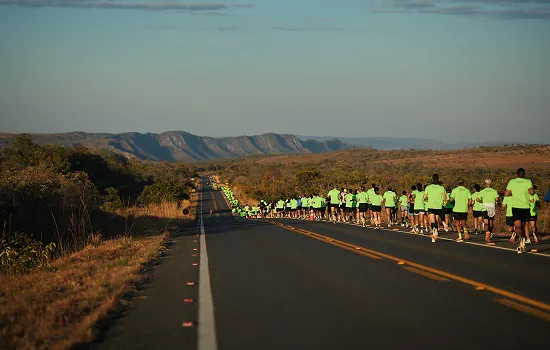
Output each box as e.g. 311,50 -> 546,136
272,222 -> 550,311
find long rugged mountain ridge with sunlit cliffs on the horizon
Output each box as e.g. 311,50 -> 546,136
0,131 -> 353,161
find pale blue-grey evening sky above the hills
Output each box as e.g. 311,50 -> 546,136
0,0 -> 550,143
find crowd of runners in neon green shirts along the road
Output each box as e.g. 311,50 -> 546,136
216,168 -> 548,253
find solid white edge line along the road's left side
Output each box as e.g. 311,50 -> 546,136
197,185 -> 218,350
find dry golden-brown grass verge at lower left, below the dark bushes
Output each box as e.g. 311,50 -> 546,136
0,232 -> 169,349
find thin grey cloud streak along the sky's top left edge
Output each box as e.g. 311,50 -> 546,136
0,0 -> 252,12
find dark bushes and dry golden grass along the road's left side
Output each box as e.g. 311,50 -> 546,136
0,135 -> 198,349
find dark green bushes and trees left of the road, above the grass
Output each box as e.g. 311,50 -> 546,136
0,134 -> 197,270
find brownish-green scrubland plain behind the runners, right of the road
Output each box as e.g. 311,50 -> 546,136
216,145 -> 550,233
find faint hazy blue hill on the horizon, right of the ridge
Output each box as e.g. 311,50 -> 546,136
298,136 -> 523,150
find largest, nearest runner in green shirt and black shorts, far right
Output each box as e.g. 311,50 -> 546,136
504,168 -> 535,254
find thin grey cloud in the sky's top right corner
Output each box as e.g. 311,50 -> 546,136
373,0 -> 550,20
